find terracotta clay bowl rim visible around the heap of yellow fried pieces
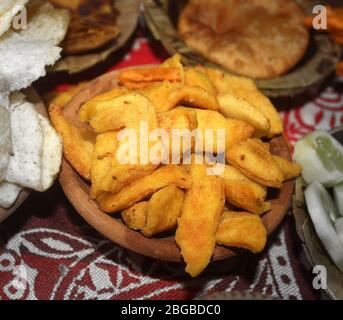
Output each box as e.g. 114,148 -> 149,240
59,66 -> 294,262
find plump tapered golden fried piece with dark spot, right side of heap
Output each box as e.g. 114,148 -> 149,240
226,139 -> 285,188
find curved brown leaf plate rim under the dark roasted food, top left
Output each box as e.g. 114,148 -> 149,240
49,0 -> 141,74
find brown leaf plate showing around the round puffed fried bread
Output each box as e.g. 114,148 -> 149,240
144,0 -> 341,98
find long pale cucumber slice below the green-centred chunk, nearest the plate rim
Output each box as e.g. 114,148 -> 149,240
305,181 -> 343,272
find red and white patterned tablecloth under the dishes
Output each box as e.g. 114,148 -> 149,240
0,27 -> 343,299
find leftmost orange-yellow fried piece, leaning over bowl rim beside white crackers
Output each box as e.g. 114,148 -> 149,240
49,104 -> 95,180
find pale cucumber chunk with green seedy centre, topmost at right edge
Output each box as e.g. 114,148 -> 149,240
294,131 -> 343,187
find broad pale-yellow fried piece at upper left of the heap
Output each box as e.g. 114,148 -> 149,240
80,93 -> 157,133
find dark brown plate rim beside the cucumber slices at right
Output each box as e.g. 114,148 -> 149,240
293,127 -> 343,300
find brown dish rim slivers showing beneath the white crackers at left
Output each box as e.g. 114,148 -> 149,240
0,87 -> 48,223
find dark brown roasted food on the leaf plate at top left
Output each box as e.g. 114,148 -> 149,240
49,0 -> 120,54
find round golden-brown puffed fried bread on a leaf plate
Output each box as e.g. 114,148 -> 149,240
178,0 -> 309,79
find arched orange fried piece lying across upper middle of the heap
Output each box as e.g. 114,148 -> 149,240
138,81 -> 219,112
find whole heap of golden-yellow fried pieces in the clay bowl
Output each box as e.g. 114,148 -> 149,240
50,55 -> 300,277
